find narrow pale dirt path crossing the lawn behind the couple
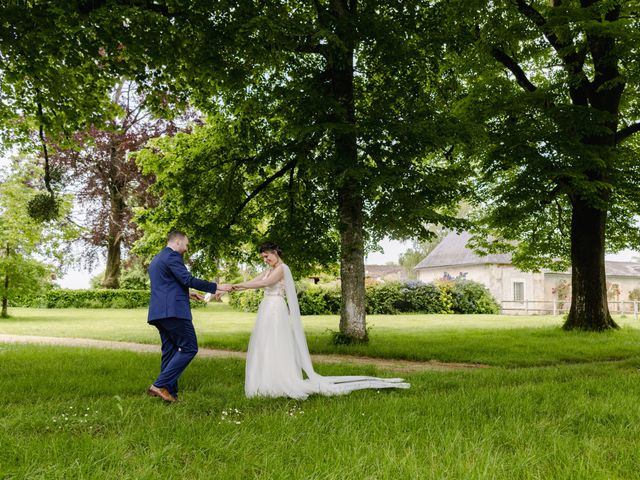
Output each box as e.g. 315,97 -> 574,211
0,334 -> 489,373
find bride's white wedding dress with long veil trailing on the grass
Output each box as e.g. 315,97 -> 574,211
244,265 -> 410,399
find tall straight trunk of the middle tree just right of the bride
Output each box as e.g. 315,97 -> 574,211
327,0 -> 367,343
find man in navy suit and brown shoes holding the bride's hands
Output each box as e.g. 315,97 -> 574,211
147,231 -> 230,402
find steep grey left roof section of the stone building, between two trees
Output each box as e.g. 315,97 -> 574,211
415,232 -> 511,270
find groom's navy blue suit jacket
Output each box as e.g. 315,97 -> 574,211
147,247 -> 217,322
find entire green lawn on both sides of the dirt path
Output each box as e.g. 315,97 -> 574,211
0,305 -> 640,480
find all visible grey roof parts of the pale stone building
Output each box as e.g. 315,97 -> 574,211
415,232 -> 640,277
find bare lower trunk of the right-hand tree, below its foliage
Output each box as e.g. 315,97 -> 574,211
563,199 -> 618,331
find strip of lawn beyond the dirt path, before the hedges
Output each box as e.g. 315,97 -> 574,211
0,304 -> 640,367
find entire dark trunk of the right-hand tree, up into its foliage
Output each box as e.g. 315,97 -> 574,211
563,0 -> 624,331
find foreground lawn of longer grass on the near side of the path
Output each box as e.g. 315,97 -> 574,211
0,344 -> 640,480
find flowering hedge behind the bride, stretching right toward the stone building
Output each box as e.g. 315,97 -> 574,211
229,280 -> 500,315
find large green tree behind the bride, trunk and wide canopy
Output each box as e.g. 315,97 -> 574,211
0,0 -> 468,339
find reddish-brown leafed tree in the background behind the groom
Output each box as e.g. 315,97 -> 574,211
52,82 -> 188,288
